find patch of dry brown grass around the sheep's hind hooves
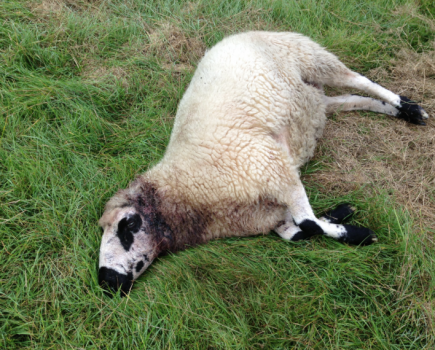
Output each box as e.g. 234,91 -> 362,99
309,50 -> 435,228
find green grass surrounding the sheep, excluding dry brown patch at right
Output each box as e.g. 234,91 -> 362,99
0,0 -> 435,349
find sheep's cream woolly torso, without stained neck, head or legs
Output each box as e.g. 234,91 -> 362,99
147,33 -> 326,238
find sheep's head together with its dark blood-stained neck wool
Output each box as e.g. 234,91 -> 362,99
98,177 -> 200,296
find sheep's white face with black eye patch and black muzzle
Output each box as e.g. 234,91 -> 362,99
98,207 -> 157,295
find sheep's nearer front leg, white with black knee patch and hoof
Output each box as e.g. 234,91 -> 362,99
276,180 -> 377,245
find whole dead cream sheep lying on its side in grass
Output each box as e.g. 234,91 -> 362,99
98,32 -> 428,295
